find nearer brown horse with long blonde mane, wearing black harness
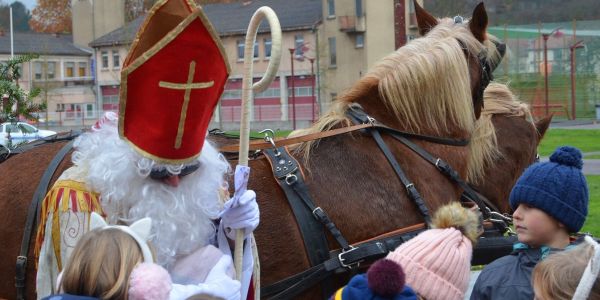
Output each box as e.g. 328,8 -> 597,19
0,4 -> 499,298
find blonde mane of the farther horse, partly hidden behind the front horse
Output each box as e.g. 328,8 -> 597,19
467,82 -> 533,183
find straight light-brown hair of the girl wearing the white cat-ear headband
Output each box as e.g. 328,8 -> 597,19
60,228 -> 143,300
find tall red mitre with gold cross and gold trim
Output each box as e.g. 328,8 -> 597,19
119,0 -> 230,164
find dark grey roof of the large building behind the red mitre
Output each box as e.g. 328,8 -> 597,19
90,0 -> 323,47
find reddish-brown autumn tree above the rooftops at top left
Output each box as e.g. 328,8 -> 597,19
29,0 -> 71,33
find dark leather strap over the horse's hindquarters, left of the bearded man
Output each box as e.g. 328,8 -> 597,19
15,141 -> 73,300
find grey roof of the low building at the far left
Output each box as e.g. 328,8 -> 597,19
0,32 -> 91,56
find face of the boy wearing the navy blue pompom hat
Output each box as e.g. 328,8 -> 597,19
513,203 -> 564,247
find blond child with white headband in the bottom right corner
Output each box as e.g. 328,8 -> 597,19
532,236 -> 600,300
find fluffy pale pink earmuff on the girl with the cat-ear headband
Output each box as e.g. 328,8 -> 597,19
129,263 -> 171,300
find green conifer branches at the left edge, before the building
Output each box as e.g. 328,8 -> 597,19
0,54 -> 46,123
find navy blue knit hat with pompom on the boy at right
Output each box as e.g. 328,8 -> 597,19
510,146 -> 589,232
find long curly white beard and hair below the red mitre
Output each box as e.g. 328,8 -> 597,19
73,120 -> 230,269
